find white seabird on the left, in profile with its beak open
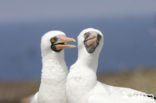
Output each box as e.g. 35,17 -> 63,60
31,31 -> 75,103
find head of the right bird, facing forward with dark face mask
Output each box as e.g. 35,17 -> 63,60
78,28 -> 104,54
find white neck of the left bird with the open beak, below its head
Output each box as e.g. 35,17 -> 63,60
38,53 -> 67,103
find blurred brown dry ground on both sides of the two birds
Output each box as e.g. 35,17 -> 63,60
0,69 -> 156,103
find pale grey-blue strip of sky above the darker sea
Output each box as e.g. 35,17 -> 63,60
0,0 -> 156,22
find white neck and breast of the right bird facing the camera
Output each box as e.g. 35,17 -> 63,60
66,50 -> 98,103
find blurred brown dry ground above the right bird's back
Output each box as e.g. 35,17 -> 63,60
98,69 -> 156,95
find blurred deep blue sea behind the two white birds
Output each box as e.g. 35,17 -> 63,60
0,17 -> 156,80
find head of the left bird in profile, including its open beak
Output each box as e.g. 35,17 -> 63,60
41,31 -> 75,55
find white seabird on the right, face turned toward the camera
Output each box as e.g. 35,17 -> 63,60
66,28 -> 156,103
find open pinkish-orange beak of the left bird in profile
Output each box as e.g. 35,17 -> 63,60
55,36 -> 76,50
